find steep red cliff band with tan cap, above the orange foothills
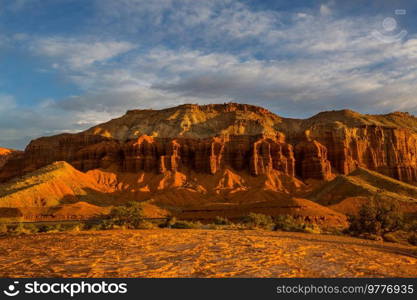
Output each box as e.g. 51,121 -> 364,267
0,103 -> 417,184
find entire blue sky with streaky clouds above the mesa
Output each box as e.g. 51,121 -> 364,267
0,0 -> 417,149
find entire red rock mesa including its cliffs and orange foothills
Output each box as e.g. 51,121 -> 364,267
0,103 -> 417,225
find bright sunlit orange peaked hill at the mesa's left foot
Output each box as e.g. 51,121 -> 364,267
0,161 -> 167,220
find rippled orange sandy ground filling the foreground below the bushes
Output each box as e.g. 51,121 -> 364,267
0,229 -> 417,277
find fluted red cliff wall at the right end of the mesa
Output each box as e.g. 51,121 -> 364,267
311,125 -> 417,184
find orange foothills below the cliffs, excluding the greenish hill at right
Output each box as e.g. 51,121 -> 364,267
0,162 -> 346,226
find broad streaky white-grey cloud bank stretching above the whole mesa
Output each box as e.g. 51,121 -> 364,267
0,0 -> 417,150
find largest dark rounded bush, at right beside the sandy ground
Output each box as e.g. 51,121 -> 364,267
348,200 -> 404,236
